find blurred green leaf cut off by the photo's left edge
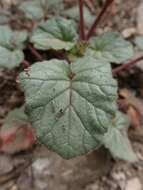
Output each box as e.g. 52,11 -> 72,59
0,26 -> 28,69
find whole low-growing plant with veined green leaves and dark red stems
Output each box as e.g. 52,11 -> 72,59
0,0 -> 142,161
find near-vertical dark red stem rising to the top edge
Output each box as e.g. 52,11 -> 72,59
78,0 -> 85,40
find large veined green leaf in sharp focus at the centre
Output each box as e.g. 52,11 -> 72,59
20,57 -> 117,159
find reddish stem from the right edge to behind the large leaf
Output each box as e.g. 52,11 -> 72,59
112,55 -> 143,76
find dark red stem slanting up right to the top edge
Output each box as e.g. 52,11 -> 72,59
86,0 -> 114,40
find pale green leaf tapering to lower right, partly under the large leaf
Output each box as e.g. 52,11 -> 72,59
102,112 -> 137,162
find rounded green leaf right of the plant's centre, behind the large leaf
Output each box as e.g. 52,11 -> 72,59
87,32 -> 133,64
